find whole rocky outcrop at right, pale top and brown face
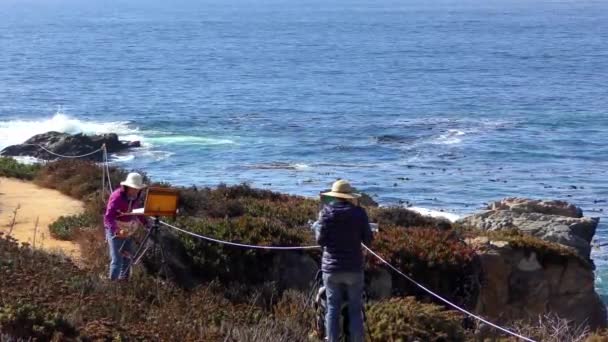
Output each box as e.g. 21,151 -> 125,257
460,198 -> 607,329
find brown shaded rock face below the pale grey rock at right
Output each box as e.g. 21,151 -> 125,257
469,237 -> 607,329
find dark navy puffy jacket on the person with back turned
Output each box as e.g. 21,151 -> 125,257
314,201 -> 373,273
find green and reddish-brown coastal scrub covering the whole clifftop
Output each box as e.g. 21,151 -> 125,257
0,158 -> 608,341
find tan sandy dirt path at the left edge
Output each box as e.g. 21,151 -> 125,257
0,177 -> 83,260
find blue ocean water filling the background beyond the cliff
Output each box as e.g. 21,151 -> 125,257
0,0 -> 608,295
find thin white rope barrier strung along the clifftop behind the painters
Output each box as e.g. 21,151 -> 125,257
22,144 -> 536,342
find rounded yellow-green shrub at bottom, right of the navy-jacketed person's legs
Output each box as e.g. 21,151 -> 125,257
367,297 -> 465,342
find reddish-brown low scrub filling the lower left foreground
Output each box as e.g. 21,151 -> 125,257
0,237 -> 306,341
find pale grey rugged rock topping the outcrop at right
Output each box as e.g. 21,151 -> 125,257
458,198 -> 599,260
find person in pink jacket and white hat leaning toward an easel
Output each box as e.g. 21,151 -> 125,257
103,173 -> 148,280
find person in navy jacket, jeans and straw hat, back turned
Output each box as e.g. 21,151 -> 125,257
314,180 -> 373,342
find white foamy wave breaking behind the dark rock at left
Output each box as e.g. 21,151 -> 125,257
0,111 -> 143,148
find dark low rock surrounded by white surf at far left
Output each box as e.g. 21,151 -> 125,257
0,132 -> 140,161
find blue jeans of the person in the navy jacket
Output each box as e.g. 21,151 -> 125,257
323,272 -> 364,342
